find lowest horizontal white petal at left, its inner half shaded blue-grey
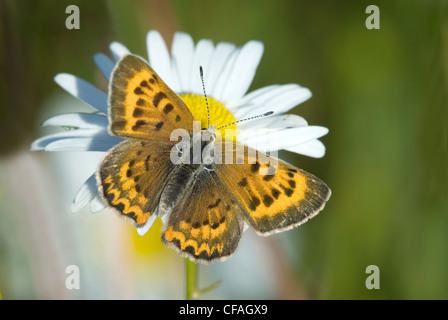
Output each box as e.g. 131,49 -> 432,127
45,135 -> 122,152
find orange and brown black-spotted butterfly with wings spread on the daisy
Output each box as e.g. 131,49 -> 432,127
97,54 -> 331,263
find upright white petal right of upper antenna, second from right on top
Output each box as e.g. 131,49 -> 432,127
204,42 -> 236,98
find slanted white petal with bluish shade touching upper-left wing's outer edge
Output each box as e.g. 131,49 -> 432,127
54,73 -> 107,114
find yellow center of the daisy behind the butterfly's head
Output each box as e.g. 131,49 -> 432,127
180,93 -> 236,141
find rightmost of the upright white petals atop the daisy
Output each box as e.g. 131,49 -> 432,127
220,41 -> 263,105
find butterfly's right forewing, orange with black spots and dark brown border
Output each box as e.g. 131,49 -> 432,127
216,143 -> 331,235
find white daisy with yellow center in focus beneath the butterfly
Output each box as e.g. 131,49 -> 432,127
31,30 -> 328,231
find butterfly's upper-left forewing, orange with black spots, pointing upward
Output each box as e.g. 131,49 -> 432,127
109,55 -> 194,142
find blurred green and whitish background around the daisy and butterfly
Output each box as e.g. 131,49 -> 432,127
0,0 -> 448,299
